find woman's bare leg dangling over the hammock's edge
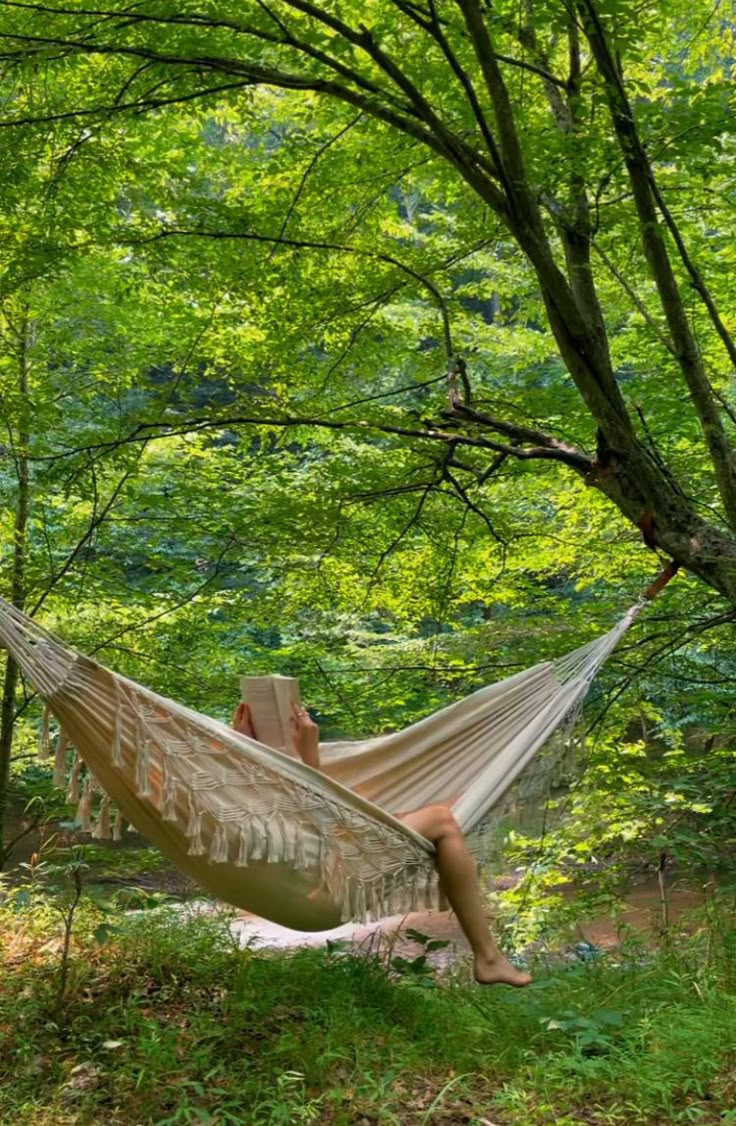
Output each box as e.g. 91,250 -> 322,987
401,805 -> 531,985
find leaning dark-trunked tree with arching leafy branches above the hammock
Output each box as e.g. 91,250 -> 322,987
2,0 -> 736,600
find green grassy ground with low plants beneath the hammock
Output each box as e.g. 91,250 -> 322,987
0,903 -> 736,1126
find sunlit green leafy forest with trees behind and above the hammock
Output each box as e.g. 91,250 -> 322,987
0,0 -> 736,932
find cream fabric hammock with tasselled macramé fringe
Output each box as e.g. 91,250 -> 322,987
0,584 -> 656,930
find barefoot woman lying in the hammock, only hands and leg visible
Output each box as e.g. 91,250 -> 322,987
233,704 -> 531,988
